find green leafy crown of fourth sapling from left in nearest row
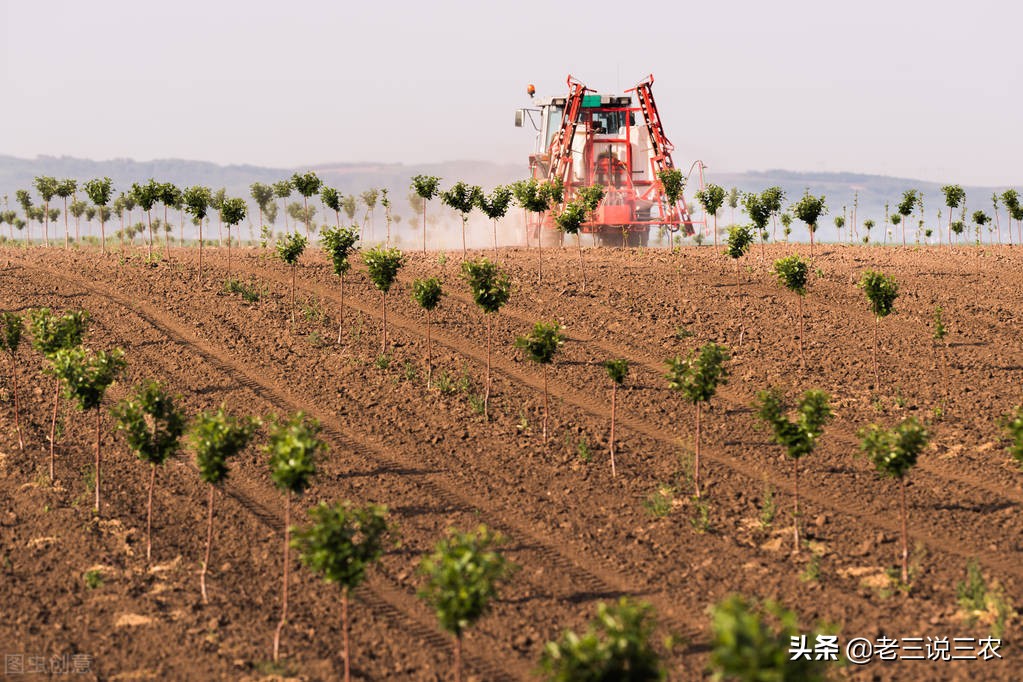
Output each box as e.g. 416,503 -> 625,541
112,381 -> 185,464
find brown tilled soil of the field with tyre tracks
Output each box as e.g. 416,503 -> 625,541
0,240 -> 1023,680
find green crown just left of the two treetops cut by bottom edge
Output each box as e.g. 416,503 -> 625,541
419,526 -> 514,637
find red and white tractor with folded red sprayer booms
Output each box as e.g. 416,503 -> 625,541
516,75 -> 703,246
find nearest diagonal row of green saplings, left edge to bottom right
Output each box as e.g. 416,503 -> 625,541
0,309 -> 847,682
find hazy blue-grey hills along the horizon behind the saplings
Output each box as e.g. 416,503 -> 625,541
0,155 -> 1005,245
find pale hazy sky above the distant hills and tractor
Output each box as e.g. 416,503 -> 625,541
0,0 -> 1023,185
